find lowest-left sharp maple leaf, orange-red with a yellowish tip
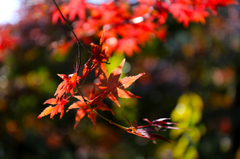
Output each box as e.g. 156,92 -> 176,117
38,96 -> 69,119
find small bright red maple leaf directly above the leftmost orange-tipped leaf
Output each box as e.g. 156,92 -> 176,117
54,73 -> 80,98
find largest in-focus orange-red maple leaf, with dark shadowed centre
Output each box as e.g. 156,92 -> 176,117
93,59 -> 144,107
